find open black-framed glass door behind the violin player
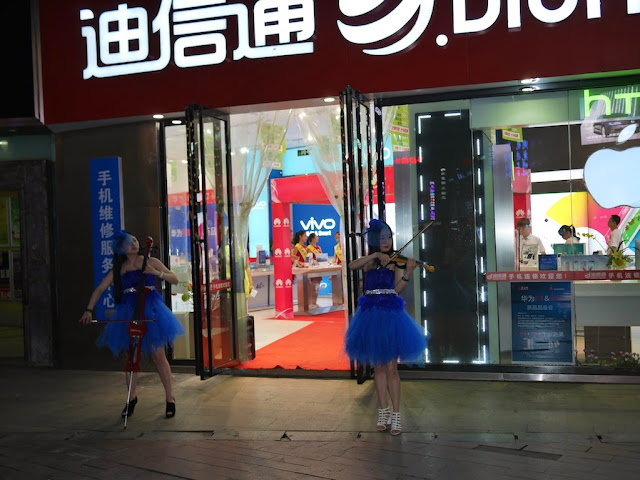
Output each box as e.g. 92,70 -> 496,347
340,86 -> 373,383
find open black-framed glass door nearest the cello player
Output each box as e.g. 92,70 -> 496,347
186,105 -> 237,378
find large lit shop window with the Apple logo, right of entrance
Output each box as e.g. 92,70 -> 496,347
480,86 -> 640,366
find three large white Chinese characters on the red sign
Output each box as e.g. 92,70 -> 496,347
80,0 -> 315,79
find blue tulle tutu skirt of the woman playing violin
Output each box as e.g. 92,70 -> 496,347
345,294 -> 427,366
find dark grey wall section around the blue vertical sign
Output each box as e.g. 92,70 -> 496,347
54,122 -> 166,370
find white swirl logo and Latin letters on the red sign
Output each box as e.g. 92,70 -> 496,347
338,0 -> 640,55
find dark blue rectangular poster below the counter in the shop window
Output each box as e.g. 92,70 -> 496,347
511,282 -> 574,365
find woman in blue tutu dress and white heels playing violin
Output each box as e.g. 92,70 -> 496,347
345,220 -> 426,435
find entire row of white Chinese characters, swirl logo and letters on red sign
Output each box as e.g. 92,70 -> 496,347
79,0 -> 640,79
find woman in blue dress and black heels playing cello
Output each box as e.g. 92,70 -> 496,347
80,231 -> 184,418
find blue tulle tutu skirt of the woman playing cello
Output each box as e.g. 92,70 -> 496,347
96,290 -> 184,356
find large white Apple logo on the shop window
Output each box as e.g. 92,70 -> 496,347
584,124 -> 640,208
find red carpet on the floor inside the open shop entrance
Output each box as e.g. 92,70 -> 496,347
238,311 -> 349,370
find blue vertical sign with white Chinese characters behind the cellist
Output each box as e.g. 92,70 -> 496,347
89,157 -> 124,320
